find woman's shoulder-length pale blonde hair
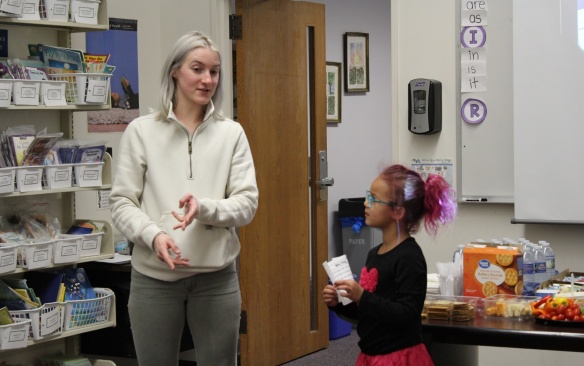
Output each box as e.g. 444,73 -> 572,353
157,31 -> 223,121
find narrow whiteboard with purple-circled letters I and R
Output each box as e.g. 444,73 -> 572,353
456,0 -> 514,203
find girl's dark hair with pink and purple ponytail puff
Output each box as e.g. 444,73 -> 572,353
380,164 -> 457,237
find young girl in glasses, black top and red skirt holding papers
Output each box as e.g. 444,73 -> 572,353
322,165 -> 456,366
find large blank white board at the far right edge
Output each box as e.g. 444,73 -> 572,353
513,0 -> 584,223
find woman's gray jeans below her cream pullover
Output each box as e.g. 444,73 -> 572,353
128,265 -> 241,366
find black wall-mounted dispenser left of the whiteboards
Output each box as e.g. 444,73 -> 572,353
408,79 -> 442,135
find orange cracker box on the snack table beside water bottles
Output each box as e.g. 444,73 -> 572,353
463,243 -> 523,297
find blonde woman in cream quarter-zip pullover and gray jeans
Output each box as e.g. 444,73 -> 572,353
110,31 -> 258,366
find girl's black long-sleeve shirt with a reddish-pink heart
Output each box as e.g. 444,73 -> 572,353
333,238 -> 427,355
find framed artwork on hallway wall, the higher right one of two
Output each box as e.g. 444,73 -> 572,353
343,32 -> 369,93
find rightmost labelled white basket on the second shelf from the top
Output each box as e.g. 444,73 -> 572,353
48,73 -> 111,105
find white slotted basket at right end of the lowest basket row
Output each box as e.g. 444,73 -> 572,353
64,287 -> 115,330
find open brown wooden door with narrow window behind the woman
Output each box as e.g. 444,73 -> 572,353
236,0 -> 328,366
